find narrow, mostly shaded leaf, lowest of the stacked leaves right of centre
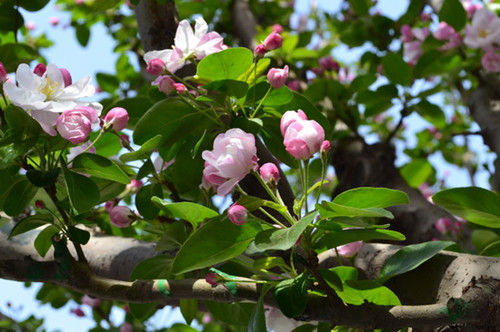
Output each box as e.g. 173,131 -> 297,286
315,229 -> 406,250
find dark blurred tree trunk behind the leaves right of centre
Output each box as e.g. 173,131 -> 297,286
332,139 -> 453,243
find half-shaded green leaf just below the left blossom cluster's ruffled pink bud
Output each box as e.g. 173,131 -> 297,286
71,153 -> 130,184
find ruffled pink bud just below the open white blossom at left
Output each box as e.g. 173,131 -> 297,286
56,106 -> 97,144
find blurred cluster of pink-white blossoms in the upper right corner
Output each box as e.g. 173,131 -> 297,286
401,2 -> 500,72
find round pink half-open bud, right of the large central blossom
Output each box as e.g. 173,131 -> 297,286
283,116 -> 325,159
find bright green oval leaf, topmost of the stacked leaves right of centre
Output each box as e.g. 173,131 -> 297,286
333,187 -> 409,209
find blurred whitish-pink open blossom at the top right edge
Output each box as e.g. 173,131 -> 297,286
464,8 -> 500,51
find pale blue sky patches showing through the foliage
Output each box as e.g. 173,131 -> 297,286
0,0 -> 494,332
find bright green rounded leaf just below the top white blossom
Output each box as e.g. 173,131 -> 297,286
196,47 -> 253,81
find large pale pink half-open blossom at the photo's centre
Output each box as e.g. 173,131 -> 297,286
201,128 -> 258,195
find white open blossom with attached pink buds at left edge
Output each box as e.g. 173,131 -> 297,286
0,64 -> 128,144
